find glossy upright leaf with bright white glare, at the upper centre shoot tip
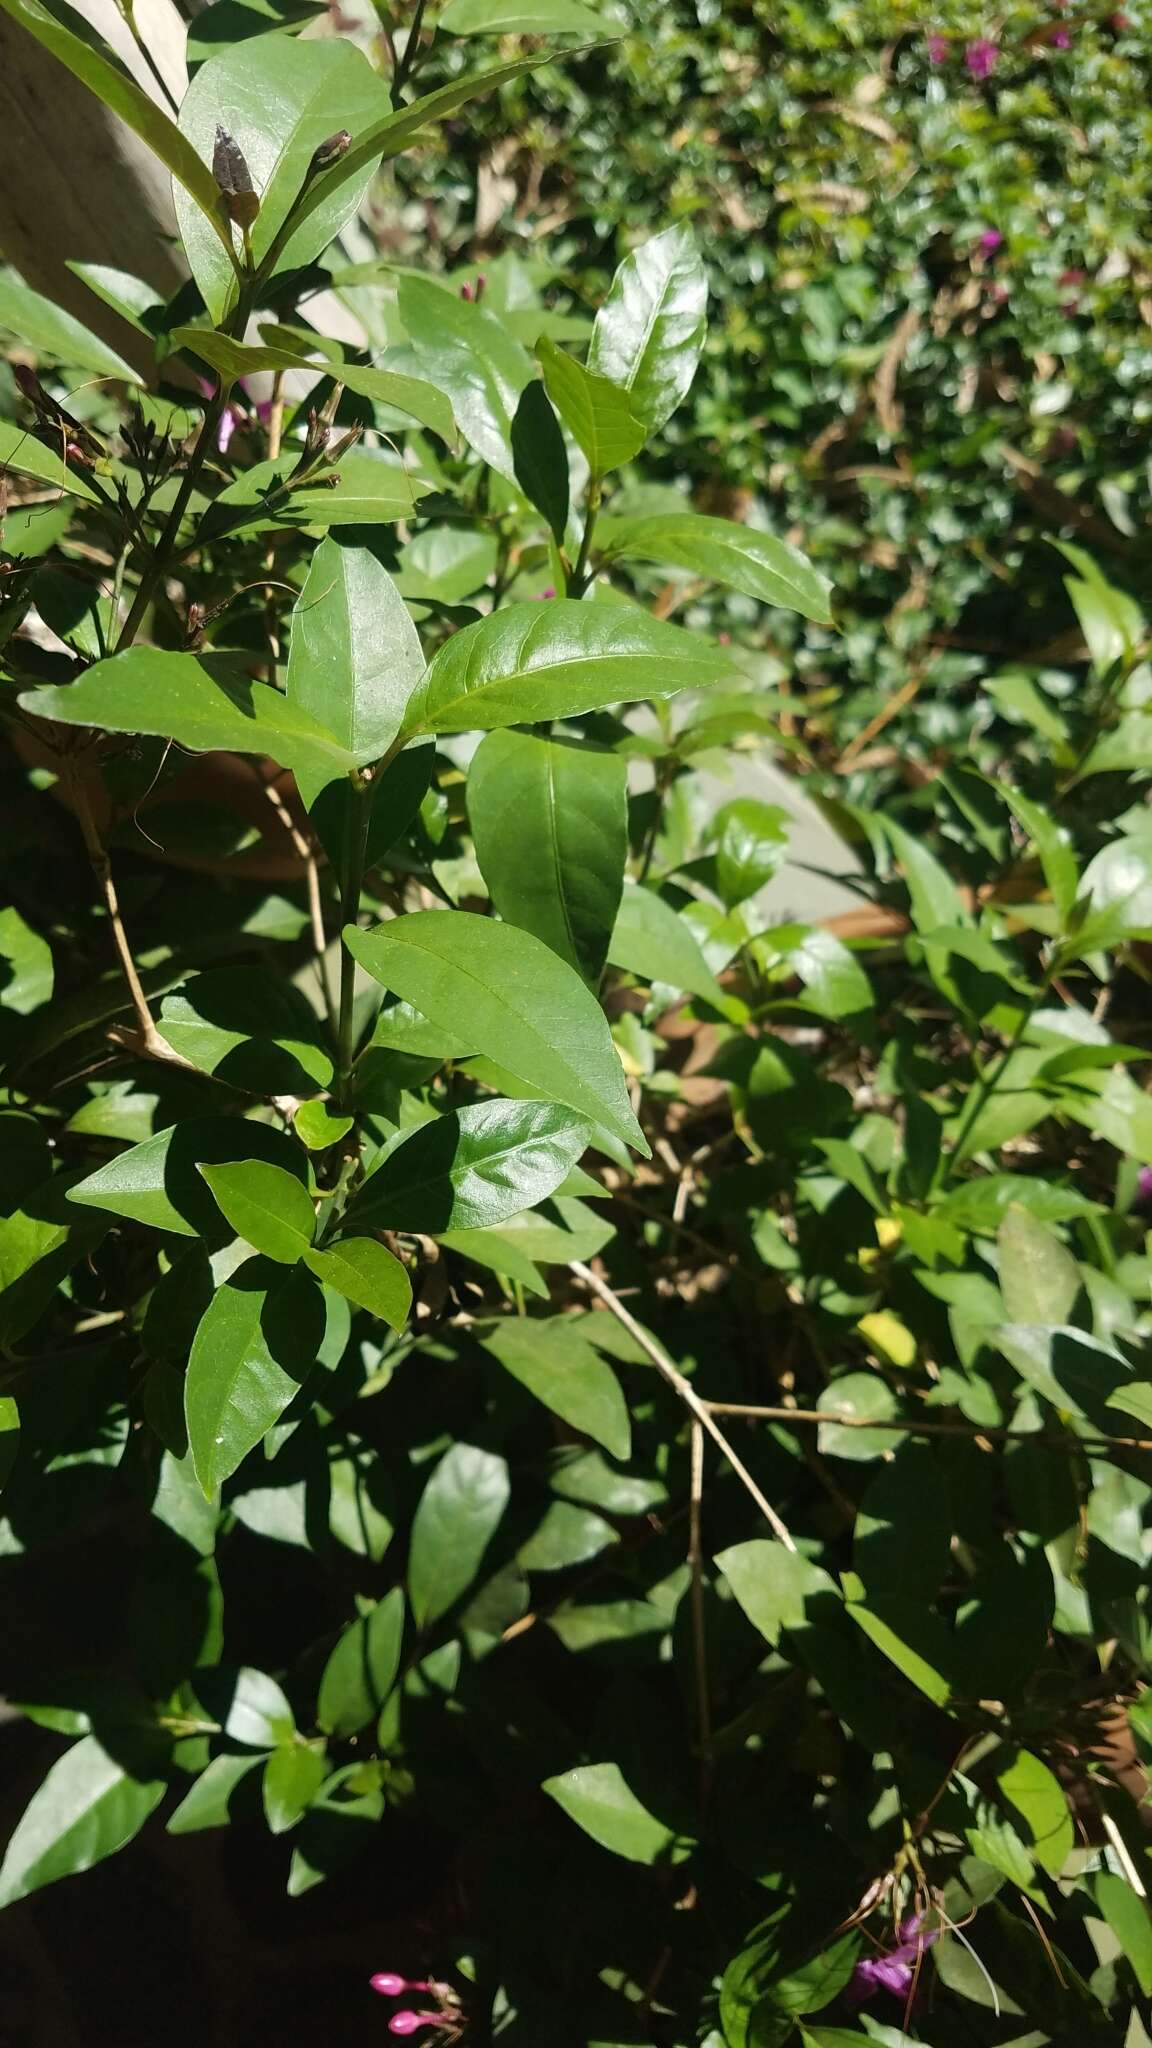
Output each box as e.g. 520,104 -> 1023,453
588,221 -> 707,430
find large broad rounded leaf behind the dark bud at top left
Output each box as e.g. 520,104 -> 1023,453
174,35 -> 389,324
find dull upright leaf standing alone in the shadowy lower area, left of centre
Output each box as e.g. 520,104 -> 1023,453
408,1444 -> 512,1628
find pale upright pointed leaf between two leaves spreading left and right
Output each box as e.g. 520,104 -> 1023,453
287,539 -> 424,768
